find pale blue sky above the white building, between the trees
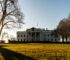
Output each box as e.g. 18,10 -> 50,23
5,0 -> 70,38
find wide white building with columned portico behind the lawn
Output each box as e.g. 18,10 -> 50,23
17,27 -> 60,42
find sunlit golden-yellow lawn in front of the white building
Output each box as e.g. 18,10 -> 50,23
0,43 -> 70,60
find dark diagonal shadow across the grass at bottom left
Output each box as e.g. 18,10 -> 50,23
0,46 -> 35,60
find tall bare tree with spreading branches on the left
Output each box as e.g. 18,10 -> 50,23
0,0 -> 23,35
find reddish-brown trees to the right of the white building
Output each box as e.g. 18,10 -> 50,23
53,15 -> 70,42
